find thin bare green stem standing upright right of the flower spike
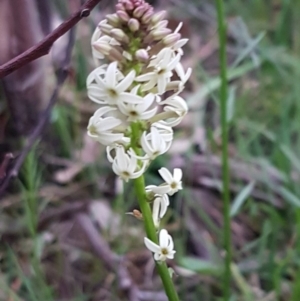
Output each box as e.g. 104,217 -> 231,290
216,0 -> 232,301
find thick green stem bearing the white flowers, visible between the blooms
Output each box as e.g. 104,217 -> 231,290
131,123 -> 179,301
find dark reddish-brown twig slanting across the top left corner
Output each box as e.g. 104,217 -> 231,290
0,0 -> 101,78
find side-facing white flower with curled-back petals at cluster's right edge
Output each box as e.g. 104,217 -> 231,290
160,95 -> 188,127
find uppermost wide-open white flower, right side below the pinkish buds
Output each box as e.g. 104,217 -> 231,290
135,48 -> 180,94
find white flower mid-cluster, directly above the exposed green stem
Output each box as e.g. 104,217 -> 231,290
118,85 -> 157,121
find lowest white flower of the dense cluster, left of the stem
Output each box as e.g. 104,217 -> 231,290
112,146 -> 148,182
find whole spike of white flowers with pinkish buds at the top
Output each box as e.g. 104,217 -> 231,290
87,0 -> 191,261
